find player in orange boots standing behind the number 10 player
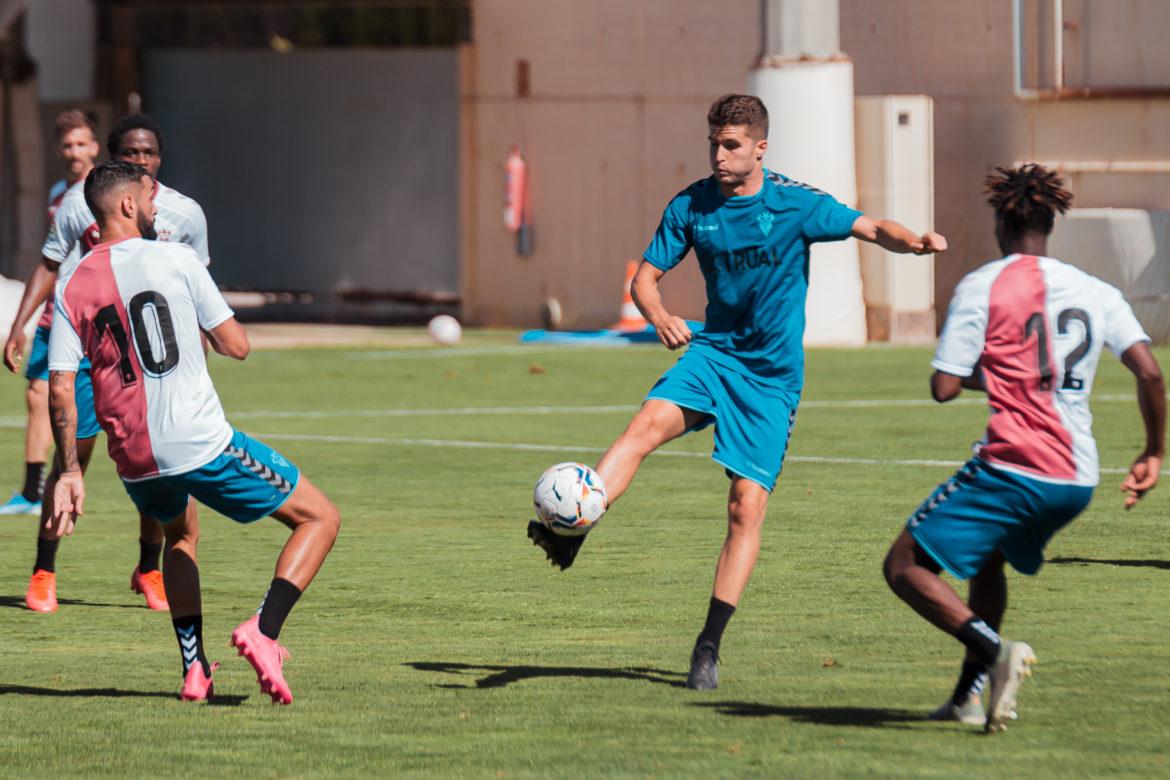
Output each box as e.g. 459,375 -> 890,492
5,113 -> 211,612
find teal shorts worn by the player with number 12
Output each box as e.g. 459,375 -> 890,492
906,457 -> 1093,580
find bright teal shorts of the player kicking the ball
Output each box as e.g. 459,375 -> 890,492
646,348 -> 800,492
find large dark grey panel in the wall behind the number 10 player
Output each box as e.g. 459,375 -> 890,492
143,48 -> 460,316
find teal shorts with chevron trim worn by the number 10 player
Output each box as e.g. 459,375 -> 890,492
122,430 -> 301,523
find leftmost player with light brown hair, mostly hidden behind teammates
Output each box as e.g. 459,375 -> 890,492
0,109 -> 101,515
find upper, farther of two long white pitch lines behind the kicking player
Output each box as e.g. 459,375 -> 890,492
223,395 -> 1136,420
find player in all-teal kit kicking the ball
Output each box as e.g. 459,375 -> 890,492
529,95 -> 947,689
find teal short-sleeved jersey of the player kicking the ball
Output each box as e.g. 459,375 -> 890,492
642,170 -> 861,393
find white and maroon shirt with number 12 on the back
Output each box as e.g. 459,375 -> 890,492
931,255 -> 1150,485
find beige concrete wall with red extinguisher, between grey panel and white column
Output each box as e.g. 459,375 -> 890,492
462,0 -> 761,327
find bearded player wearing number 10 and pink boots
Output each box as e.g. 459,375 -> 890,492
48,160 -> 340,704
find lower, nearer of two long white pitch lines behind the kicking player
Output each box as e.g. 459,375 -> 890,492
248,432 -> 1170,474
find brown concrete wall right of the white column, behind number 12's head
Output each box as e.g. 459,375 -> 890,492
840,0 -> 1170,312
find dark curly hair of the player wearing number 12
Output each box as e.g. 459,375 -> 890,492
983,163 -> 1073,235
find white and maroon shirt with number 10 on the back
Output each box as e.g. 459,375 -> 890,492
49,239 -> 233,482
